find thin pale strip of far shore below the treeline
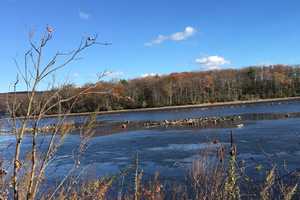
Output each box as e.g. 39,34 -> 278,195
31,96 -> 300,118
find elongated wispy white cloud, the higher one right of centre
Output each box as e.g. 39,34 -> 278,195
145,26 -> 197,46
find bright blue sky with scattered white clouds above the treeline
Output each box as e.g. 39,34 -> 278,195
0,0 -> 300,92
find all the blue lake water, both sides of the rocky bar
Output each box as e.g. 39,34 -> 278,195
0,101 -> 300,186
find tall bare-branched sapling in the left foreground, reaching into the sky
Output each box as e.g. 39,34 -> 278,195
8,26 -> 109,199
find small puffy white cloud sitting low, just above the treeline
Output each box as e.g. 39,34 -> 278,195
195,56 -> 230,70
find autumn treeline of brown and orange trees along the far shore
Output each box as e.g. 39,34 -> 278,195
2,65 -> 300,114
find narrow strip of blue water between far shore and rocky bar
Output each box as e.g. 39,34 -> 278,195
0,100 -> 300,131
